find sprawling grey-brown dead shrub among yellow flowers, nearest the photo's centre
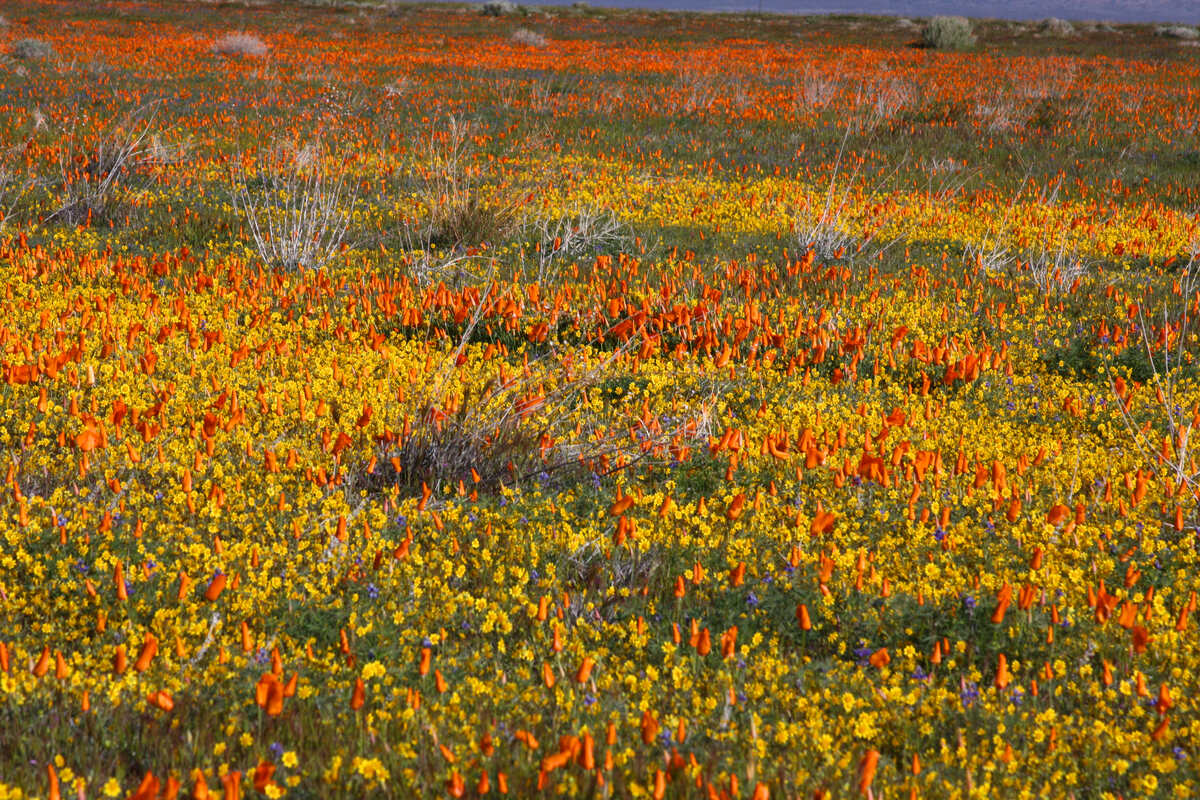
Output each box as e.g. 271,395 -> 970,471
354,282 -> 715,497
